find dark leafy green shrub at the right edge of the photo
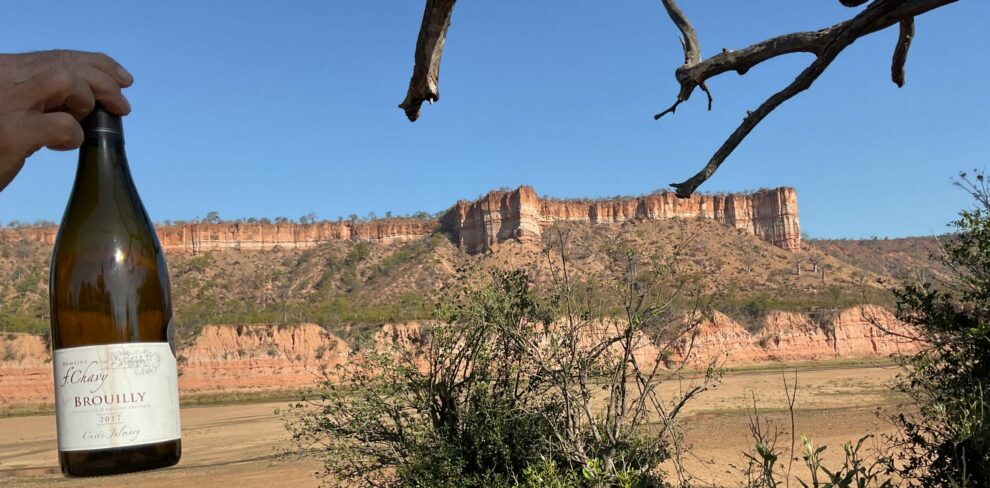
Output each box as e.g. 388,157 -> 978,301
888,172 -> 990,486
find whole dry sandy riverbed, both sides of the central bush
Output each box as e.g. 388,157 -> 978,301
0,365 -> 912,488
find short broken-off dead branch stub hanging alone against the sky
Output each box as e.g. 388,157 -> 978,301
399,0 -> 456,122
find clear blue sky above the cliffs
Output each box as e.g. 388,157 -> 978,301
0,0 -> 990,237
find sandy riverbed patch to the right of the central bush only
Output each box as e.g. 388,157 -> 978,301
665,366 -> 904,487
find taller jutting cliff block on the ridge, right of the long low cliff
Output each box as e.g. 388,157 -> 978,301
440,186 -> 801,253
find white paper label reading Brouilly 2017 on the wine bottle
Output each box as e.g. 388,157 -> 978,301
52,342 -> 180,451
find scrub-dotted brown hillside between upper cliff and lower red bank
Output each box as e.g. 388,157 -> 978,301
0,219 -> 936,340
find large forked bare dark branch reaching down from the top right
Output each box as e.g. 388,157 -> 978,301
668,0 -> 956,198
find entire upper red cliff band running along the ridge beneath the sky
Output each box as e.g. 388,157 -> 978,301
0,186 -> 801,254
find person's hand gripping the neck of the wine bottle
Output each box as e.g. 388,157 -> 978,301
0,50 -> 134,191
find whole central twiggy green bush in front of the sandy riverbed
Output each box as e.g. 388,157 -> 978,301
285,246 -> 709,488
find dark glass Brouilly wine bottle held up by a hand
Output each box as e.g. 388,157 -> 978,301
49,106 -> 182,476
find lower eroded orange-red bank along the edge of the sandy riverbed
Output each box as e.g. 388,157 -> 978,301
0,306 -> 918,407
